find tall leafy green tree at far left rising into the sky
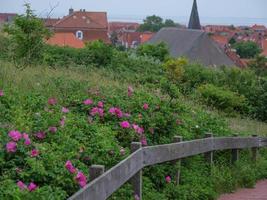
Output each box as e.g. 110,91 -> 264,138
4,3 -> 50,67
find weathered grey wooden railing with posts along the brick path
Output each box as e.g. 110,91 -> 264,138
69,134 -> 267,200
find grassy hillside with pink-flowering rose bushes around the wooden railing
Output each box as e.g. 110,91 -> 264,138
0,59 -> 267,200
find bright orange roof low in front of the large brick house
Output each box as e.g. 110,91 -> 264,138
47,33 -> 85,48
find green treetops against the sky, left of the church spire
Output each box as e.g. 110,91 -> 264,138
138,15 -> 177,32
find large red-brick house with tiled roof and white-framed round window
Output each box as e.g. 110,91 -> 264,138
45,8 -> 110,43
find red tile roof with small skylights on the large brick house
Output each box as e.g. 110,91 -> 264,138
54,11 -> 108,29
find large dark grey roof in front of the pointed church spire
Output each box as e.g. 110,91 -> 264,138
148,28 -> 235,66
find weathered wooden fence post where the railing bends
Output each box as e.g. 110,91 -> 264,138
130,142 -> 142,200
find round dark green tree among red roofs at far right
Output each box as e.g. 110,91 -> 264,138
233,41 -> 261,58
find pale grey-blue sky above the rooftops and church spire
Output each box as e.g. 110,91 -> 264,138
0,0 -> 267,25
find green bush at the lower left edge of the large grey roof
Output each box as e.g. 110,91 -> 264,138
136,42 -> 169,61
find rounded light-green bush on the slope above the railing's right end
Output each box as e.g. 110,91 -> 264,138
198,84 -> 246,112
